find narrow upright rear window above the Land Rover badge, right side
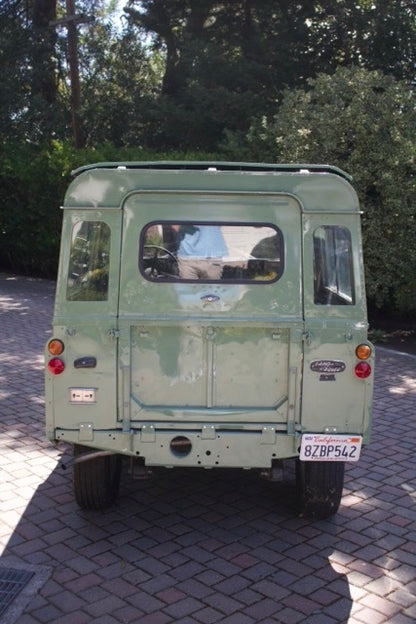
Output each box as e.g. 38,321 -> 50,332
313,225 -> 355,305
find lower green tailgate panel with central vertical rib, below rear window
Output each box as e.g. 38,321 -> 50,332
130,325 -> 289,420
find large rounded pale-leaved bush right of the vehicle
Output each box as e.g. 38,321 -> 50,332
228,68 -> 416,311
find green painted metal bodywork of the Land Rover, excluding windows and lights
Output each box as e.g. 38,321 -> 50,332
46,163 -> 373,468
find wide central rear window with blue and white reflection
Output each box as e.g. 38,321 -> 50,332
139,222 -> 283,282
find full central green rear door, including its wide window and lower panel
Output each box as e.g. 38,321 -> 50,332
119,192 -> 303,430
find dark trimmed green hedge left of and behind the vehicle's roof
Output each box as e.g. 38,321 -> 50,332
0,141 -> 219,278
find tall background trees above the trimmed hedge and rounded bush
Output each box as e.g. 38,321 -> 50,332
0,0 -> 416,150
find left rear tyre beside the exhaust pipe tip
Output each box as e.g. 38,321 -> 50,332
72,444 -> 121,509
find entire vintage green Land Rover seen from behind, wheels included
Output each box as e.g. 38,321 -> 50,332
46,162 -> 373,517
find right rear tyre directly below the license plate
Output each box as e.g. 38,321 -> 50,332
296,459 -> 345,519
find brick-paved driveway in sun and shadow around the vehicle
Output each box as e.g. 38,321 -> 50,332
0,275 -> 416,624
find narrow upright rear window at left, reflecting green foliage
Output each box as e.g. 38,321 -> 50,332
66,221 -> 111,301
